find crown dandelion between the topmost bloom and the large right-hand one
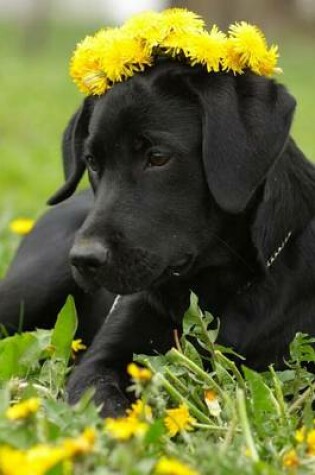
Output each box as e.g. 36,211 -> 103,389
187,25 -> 226,72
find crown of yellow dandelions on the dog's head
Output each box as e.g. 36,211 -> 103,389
70,8 -> 281,95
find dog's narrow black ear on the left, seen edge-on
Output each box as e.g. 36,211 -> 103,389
47,97 -> 93,205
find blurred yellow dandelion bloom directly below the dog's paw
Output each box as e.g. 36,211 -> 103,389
105,416 -> 149,441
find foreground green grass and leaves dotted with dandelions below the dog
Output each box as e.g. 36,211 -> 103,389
0,295 -> 315,475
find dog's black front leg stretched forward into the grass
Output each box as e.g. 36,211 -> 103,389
68,292 -> 175,416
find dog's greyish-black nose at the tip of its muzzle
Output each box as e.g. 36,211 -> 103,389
70,242 -> 109,273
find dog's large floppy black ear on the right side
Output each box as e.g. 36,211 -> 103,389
194,72 -> 295,213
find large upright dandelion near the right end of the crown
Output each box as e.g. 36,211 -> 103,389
229,21 -> 267,68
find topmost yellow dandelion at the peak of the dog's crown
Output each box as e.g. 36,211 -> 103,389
161,8 -> 205,33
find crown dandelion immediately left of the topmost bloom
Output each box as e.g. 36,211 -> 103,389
122,11 -> 168,49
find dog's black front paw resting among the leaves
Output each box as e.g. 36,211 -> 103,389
67,366 -> 130,417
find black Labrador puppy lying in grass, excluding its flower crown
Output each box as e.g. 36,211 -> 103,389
0,61 -> 315,415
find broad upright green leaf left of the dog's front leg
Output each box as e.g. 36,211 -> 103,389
51,297 -> 77,366
